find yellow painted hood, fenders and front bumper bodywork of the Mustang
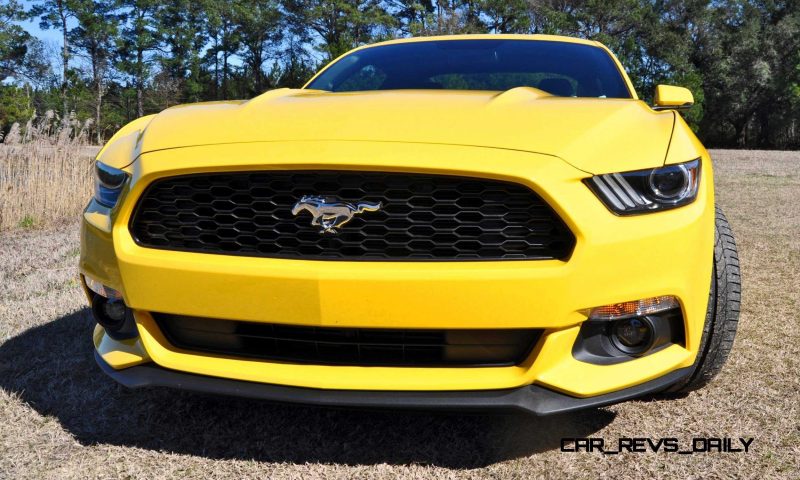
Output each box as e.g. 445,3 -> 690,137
80,36 -> 714,397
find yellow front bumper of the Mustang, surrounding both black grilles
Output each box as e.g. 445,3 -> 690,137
80,142 -> 713,398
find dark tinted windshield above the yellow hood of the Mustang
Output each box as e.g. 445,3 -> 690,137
306,40 -> 631,98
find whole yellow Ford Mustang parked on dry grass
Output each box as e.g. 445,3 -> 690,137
80,35 -> 740,415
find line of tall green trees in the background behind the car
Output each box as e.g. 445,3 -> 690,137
0,0 -> 800,149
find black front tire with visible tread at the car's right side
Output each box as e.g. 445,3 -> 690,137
667,207 -> 742,393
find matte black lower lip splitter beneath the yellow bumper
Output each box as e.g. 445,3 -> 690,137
94,351 -> 691,416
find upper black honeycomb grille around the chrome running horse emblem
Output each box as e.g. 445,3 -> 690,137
131,171 -> 575,260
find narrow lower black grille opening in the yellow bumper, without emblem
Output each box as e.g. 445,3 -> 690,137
153,313 -> 542,367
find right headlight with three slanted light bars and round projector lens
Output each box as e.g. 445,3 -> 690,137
585,158 -> 700,215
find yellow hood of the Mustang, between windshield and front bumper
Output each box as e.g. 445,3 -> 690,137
138,87 -> 675,174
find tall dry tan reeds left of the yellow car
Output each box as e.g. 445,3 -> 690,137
0,112 -> 99,230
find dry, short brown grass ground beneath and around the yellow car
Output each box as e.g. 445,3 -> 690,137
0,151 -> 800,479
